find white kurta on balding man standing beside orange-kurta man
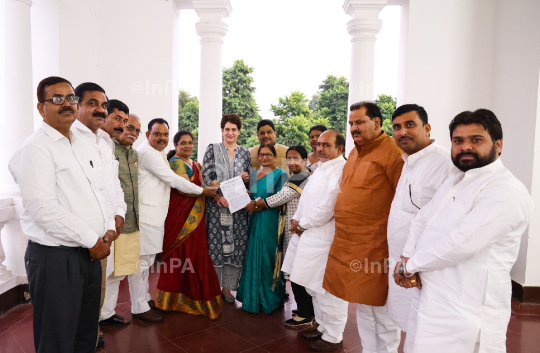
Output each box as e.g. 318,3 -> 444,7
281,156 -> 345,293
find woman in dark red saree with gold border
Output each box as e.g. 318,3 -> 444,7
155,130 -> 221,320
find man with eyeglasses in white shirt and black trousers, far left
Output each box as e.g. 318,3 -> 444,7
9,77 -> 114,353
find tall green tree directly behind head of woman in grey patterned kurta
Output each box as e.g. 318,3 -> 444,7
223,60 -> 261,147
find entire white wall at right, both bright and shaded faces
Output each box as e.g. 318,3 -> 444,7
398,0 -> 540,286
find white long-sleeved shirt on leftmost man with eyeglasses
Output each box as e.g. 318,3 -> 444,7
9,122 -> 114,248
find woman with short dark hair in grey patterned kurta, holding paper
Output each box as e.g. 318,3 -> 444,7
203,114 -> 251,303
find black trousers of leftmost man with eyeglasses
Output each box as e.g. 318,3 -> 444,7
24,242 -> 101,353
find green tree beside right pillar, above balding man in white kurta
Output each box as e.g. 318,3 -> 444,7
315,75 -> 349,134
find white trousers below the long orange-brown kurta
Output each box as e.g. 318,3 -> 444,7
356,304 -> 401,353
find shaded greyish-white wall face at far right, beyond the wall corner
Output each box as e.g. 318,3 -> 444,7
492,0 -> 540,286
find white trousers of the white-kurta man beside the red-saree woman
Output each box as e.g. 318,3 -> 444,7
128,254 -> 156,314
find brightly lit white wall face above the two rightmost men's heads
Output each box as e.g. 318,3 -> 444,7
400,0 -> 495,147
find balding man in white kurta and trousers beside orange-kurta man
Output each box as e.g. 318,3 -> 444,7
281,130 -> 348,352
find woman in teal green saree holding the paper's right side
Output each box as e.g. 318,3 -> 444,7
236,144 -> 289,314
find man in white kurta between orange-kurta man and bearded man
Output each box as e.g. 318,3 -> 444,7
387,104 -> 453,352
